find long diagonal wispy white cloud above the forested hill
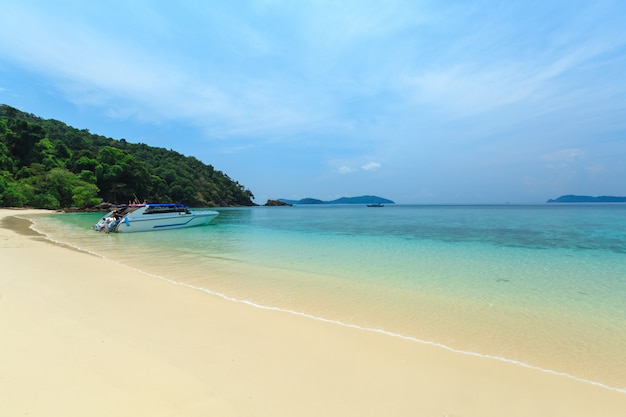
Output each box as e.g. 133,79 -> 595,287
0,2 -> 332,136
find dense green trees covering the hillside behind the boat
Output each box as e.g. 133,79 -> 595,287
0,105 -> 254,209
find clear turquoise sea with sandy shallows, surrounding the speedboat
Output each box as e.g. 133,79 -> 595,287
25,204 -> 626,393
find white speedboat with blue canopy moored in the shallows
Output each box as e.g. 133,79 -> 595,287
93,204 -> 219,233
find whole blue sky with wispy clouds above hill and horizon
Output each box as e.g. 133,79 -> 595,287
0,0 -> 626,204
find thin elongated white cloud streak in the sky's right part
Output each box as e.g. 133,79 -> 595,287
407,40 -> 623,117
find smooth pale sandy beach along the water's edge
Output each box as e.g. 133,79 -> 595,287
0,209 -> 626,417
